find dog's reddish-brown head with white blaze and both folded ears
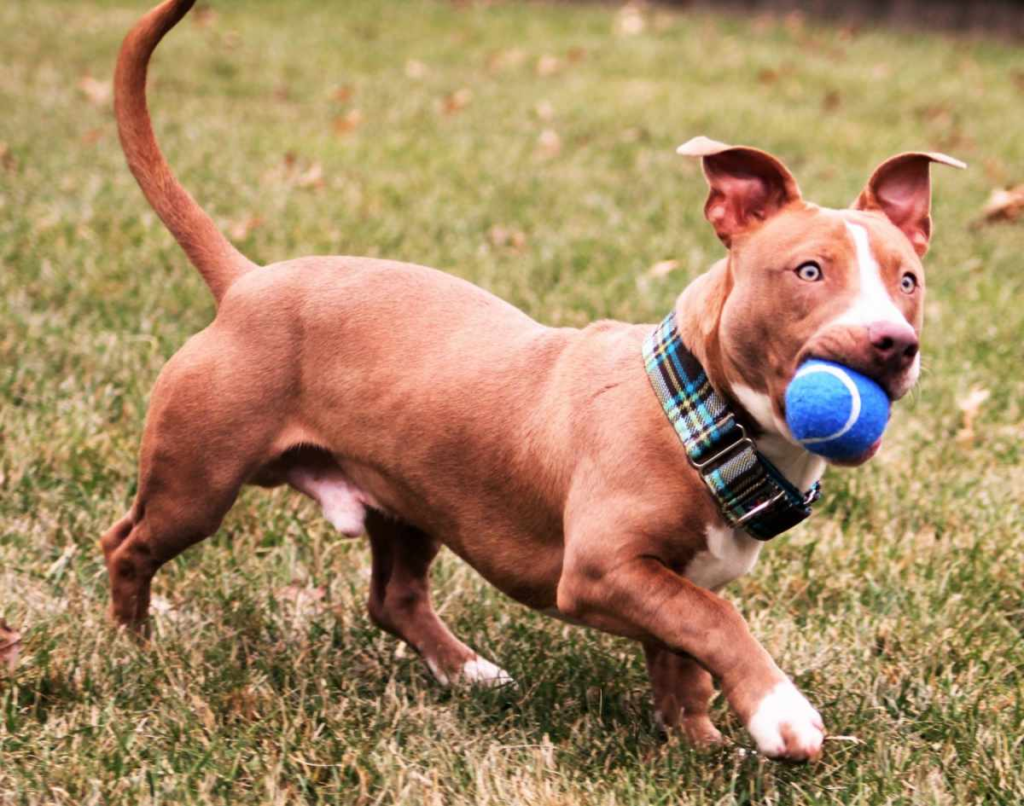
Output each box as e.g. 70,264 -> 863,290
679,137 -> 964,456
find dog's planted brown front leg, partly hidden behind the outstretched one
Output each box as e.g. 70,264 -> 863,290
644,644 -> 722,747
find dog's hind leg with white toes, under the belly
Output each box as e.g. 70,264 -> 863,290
366,510 -> 512,685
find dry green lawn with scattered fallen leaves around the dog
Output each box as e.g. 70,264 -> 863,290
0,0 -> 1024,806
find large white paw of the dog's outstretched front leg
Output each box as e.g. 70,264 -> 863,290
746,680 -> 825,761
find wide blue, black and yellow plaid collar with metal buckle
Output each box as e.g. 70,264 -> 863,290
643,310 -> 821,540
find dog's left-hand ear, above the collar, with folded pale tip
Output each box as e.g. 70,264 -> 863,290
676,137 -> 801,246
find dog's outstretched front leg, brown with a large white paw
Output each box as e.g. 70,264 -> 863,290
558,536 -> 824,761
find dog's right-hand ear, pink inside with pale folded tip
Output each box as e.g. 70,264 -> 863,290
852,152 -> 967,257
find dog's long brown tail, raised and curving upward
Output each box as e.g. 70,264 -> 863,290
114,0 -> 256,302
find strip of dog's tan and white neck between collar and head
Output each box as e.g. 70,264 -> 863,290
676,258 -> 825,491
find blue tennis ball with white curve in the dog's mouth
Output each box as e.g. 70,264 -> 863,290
785,358 -> 889,461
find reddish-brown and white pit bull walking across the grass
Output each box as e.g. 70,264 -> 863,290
102,0 -> 957,760
